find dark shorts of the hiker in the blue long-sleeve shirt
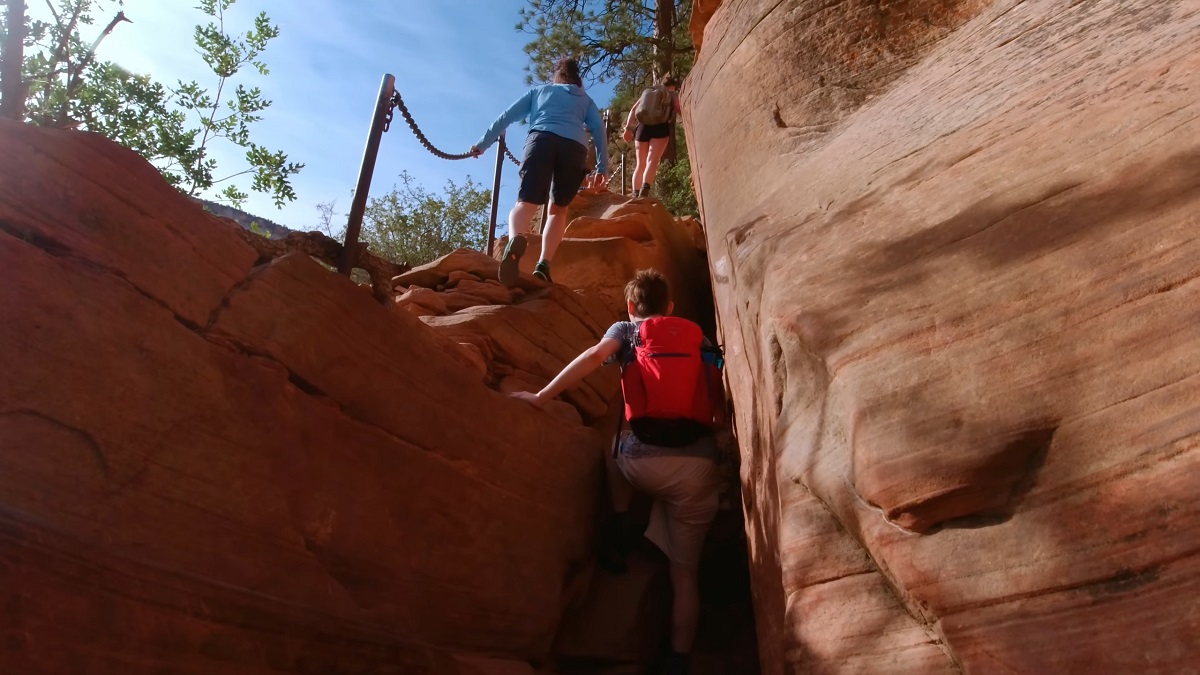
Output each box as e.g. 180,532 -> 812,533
517,131 -> 588,207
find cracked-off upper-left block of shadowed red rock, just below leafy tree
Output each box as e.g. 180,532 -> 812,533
0,120 -> 257,325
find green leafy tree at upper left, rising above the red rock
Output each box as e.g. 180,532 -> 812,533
0,0 -> 304,207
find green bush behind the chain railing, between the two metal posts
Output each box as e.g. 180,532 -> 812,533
355,172 -> 492,265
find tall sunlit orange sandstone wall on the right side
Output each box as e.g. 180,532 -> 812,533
683,0 -> 1200,674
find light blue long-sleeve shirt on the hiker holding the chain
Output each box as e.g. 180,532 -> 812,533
475,84 -> 608,174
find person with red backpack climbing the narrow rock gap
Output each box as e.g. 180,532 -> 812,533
512,269 -> 725,675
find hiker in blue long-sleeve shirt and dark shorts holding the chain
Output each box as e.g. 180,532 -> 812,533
470,59 -> 608,286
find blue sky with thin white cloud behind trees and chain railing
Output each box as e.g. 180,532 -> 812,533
41,0 -> 611,229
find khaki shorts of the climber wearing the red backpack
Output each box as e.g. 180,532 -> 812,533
617,454 -> 721,565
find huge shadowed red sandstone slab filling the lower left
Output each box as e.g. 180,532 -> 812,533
0,123 -> 614,675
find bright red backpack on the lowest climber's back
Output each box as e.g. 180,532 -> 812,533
620,316 -> 725,447
